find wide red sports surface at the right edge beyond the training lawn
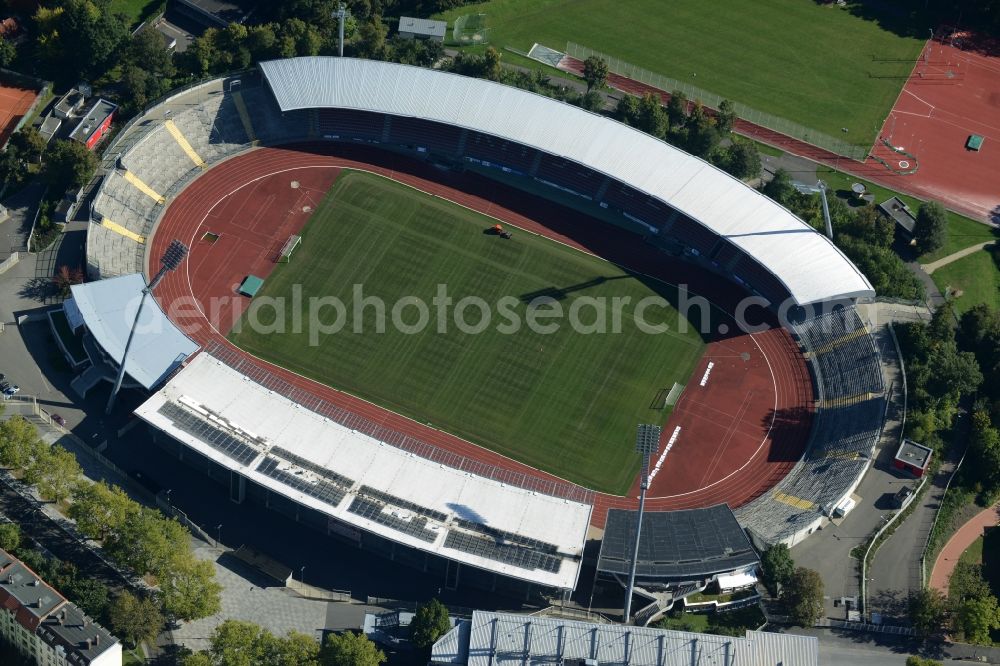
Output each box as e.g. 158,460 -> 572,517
873,33 -> 1000,221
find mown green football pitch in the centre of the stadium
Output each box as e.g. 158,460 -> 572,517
230,171 -> 704,494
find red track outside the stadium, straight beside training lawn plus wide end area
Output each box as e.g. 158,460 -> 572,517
558,48 -> 1000,222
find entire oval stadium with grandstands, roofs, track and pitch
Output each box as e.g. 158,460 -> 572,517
66,57 -> 886,623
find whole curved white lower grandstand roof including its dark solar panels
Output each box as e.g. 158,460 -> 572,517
135,352 -> 591,589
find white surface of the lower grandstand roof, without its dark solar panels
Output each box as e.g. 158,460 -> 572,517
135,353 -> 592,588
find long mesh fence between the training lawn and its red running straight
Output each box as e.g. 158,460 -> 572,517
566,42 -> 868,162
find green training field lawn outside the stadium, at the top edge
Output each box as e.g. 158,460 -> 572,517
440,0 -> 923,147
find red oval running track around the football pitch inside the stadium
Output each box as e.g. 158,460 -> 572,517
149,144 -> 812,527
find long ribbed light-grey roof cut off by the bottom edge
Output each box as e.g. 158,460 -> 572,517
431,610 -> 819,666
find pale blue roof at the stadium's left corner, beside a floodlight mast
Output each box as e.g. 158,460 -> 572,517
70,273 -> 198,389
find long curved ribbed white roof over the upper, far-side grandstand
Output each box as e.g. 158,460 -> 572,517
260,56 -> 875,305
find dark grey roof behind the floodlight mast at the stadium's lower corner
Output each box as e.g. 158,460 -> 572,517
597,504 -> 758,580
